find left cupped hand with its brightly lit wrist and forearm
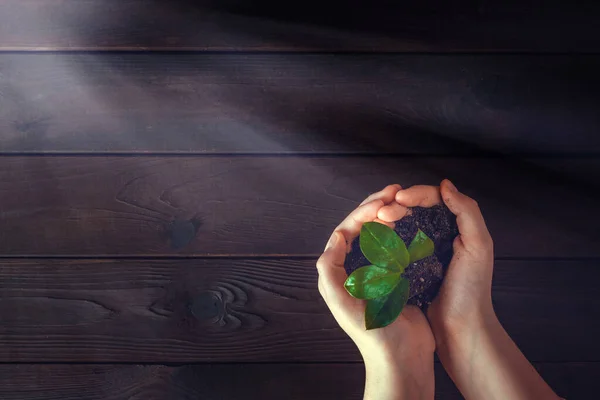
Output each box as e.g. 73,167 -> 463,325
317,185 -> 435,400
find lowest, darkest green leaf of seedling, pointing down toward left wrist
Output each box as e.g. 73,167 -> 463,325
365,278 -> 409,330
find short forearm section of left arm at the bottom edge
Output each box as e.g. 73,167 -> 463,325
364,353 -> 435,400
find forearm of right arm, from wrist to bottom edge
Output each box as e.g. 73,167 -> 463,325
434,315 -> 559,400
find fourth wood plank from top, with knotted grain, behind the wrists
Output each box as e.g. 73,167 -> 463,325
0,259 -> 600,363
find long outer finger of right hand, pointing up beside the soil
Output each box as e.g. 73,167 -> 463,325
441,179 -> 492,249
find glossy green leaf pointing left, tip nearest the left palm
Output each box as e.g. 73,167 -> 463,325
344,265 -> 400,300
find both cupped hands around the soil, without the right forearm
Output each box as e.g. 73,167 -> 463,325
317,180 -> 495,399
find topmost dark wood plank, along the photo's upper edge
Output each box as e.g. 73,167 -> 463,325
0,0 -> 600,52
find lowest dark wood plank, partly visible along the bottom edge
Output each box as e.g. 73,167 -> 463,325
0,363 -> 600,400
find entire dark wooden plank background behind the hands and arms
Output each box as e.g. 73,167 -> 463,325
0,0 -> 600,400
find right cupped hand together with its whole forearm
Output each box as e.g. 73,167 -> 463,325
377,180 -> 558,400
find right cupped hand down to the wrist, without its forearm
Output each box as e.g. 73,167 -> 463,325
378,180 -> 496,344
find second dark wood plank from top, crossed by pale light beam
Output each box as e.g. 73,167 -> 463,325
0,55 -> 600,155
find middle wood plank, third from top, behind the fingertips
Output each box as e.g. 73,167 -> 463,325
0,156 -> 600,257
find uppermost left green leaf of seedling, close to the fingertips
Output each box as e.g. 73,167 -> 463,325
360,222 -> 410,273
